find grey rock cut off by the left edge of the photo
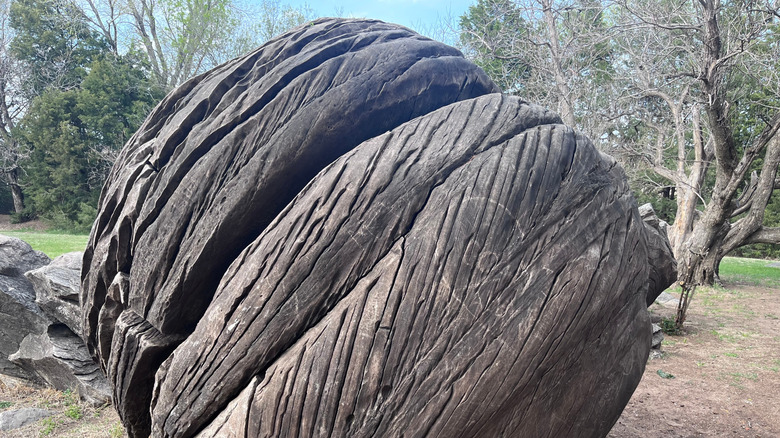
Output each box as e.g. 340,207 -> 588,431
0,235 -> 50,383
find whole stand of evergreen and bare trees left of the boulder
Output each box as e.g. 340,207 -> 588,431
0,0 -> 313,230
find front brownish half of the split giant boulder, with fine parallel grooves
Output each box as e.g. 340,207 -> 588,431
151,95 -> 651,437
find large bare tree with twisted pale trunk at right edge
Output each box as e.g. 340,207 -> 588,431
616,0 -> 780,325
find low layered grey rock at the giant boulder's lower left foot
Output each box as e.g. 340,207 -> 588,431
9,324 -> 111,406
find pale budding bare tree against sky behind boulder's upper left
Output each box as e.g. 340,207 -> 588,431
75,0 -> 314,89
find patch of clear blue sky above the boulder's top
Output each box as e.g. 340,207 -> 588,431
282,0 -> 476,33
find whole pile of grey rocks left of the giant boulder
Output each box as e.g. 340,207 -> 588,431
0,235 -> 111,405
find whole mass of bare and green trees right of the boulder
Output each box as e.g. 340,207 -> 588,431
461,0 -> 780,326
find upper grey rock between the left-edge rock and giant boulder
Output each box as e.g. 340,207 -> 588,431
24,252 -> 84,333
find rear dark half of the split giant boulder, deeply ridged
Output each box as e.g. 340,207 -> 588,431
81,19 -> 497,436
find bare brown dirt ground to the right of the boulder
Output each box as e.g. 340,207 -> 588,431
609,284 -> 780,438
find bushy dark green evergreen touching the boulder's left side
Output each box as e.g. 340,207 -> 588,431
21,56 -> 163,229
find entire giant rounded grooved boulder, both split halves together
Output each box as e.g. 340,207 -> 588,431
81,19 -> 671,437
